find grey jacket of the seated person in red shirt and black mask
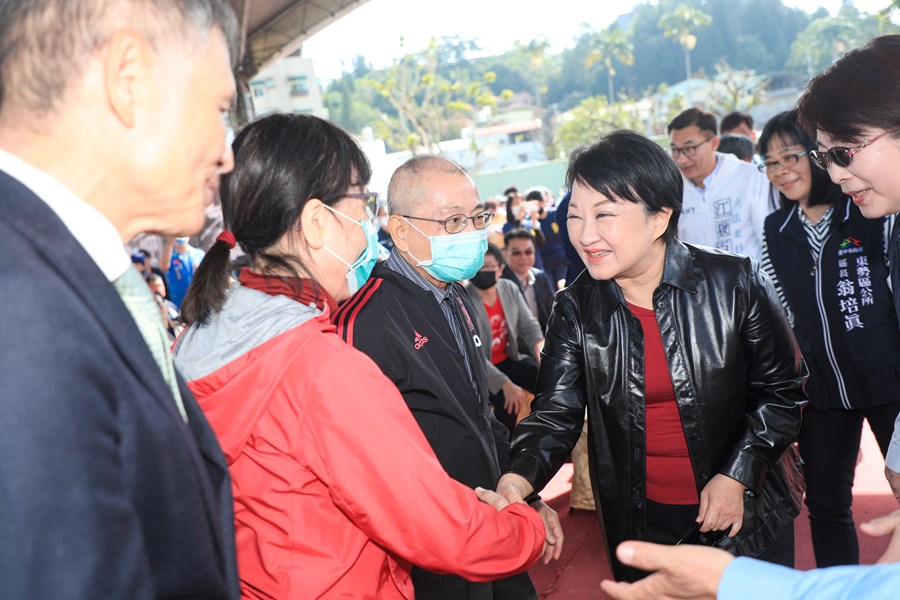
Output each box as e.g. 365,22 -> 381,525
466,277 -> 544,394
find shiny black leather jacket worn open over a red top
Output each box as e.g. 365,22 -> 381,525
511,241 -> 808,579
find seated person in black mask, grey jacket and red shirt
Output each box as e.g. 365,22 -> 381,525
466,244 -> 544,434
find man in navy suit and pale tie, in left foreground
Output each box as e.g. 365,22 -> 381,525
0,0 -> 239,599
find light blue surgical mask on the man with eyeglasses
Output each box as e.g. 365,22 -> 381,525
406,219 -> 488,283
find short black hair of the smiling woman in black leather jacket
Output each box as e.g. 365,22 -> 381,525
566,130 -> 684,242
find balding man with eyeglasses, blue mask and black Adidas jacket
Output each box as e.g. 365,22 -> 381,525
334,156 -> 562,600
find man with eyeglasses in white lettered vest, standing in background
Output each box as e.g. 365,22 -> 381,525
668,108 -> 775,260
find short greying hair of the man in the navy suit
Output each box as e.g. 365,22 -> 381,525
0,0 -> 240,115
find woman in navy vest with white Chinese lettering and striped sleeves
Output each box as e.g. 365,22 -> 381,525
759,111 -> 900,567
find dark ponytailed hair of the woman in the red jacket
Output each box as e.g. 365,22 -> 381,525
182,114 -> 372,324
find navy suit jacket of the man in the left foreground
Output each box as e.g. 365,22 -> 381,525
0,173 -> 239,599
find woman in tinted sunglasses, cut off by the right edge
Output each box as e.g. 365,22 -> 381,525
797,35 -> 900,501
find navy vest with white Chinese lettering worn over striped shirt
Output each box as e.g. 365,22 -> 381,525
764,199 -> 900,410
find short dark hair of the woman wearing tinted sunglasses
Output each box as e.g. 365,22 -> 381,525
797,35 -> 900,143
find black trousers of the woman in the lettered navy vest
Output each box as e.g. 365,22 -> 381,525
797,402 -> 900,568
